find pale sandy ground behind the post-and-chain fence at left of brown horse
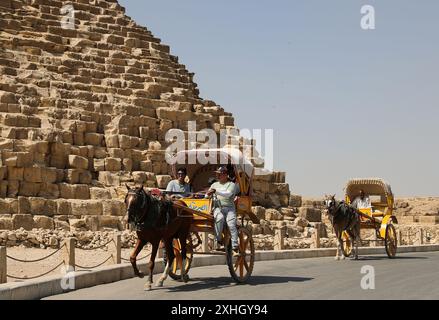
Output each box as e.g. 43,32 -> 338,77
7,247 -> 149,282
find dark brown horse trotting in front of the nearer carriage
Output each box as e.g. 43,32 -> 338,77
125,186 -> 193,291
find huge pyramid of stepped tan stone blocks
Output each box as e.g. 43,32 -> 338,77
0,0 -> 290,230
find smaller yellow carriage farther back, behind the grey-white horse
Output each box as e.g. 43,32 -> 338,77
342,179 -> 398,258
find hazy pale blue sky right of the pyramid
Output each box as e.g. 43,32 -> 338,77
120,0 -> 439,196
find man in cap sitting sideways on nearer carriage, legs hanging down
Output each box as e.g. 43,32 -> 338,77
206,166 -> 239,255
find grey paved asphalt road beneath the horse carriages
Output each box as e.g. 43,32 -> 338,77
43,252 -> 439,300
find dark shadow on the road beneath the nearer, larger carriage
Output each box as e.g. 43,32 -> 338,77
164,276 -> 314,292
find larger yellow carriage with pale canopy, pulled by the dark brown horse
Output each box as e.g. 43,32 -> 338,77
169,149 -> 259,283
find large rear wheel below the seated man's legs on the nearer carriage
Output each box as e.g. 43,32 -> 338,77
226,226 -> 255,283
